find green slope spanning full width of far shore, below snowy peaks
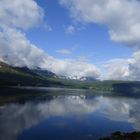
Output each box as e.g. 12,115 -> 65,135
0,62 -> 140,93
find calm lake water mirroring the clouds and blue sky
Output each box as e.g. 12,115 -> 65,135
0,89 -> 140,140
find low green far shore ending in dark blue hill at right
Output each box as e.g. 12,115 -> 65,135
45,79 -> 140,95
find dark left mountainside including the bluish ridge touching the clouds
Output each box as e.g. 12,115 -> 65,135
0,62 -> 63,86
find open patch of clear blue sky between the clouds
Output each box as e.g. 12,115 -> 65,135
27,0 -> 132,65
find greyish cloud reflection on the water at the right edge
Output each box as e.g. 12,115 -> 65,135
101,98 -> 140,131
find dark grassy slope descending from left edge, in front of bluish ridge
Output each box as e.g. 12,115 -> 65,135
0,62 -> 64,86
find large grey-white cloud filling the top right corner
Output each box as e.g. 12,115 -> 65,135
60,0 -> 140,47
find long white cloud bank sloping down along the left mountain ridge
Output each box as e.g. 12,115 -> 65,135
0,28 -> 100,78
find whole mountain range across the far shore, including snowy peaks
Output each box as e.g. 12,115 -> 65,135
0,62 -> 140,96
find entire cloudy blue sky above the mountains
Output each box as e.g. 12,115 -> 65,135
0,0 -> 140,80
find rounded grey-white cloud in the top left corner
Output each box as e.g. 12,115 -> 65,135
0,0 -> 44,29
